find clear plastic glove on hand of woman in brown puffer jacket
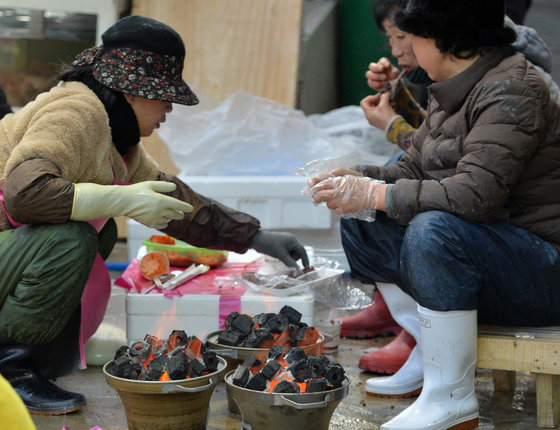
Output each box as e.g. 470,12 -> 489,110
311,175 -> 384,222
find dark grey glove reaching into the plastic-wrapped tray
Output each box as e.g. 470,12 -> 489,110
253,230 -> 309,269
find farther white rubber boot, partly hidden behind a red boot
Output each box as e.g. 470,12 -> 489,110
366,282 -> 424,397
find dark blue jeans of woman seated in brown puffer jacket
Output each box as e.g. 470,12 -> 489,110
341,211 -> 560,326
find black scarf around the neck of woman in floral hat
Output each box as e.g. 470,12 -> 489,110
58,66 -> 140,155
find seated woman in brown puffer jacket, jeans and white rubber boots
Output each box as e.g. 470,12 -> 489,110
310,0 -> 560,430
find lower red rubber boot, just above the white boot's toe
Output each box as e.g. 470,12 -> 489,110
358,330 -> 416,375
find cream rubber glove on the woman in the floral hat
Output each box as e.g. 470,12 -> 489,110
71,181 -> 193,229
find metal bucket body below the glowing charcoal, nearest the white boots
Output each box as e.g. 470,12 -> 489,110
225,372 -> 350,430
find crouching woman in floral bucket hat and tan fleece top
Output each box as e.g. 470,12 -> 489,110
0,16 -> 309,414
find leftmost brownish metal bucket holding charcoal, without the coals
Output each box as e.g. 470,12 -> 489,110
103,357 -> 227,430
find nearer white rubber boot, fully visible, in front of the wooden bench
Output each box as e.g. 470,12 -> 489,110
381,306 -> 478,430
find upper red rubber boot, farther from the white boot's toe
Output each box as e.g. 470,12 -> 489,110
337,291 -> 402,339
